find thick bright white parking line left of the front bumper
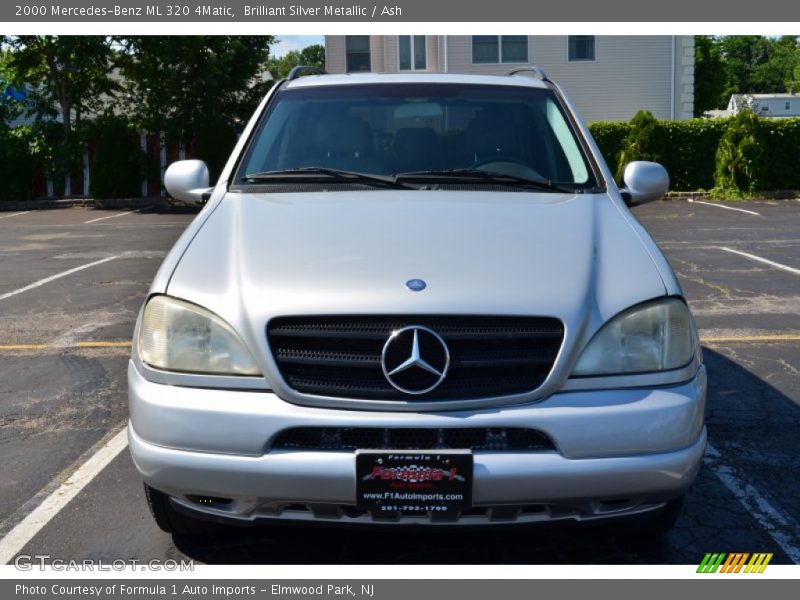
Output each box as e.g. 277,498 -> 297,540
0,427 -> 128,565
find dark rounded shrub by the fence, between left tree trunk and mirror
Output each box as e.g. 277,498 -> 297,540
89,117 -> 148,198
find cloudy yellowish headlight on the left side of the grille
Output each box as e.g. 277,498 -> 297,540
139,296 -> 261,375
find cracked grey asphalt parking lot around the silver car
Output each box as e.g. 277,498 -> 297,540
0,201 -> 800,564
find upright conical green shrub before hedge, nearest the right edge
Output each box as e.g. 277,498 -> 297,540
714,110 -> 766,197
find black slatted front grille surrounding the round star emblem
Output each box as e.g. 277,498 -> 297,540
267,316 -> 564,401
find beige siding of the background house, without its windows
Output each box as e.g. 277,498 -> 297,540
325,35 -> 694,121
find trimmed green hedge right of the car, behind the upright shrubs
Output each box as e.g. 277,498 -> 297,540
589,118 -> 800,191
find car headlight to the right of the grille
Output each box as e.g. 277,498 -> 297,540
572,298 -> 694,376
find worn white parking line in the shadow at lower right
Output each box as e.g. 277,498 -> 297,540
703,444 -> 800,564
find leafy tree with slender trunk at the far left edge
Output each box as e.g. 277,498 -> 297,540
4,35 -> 117,195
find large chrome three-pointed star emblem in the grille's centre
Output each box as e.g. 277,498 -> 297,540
381,325 -> 450,395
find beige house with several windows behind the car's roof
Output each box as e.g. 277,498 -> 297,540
325,35 -> 694,121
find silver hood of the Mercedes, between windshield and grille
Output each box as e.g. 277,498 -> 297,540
167,190 -> 666,380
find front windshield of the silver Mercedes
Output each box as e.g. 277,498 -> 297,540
236,83 -> 594,189
